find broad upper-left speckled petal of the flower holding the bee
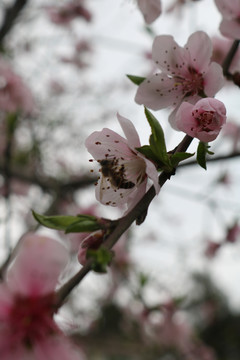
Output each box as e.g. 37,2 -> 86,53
85,128 -> 131,160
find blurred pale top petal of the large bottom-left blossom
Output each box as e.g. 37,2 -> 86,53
7,234 -> 68,296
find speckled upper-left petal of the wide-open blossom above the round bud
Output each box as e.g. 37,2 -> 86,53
152,35 -> 187,75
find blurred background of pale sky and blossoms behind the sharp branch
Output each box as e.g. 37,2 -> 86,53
0,0 -> 240,360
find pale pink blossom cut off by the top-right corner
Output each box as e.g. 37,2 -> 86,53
215,0 -> 240,39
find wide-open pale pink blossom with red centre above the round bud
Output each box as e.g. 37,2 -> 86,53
135,31 -> 223,122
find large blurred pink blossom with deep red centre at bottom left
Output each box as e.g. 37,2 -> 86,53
0,235 -> 82,360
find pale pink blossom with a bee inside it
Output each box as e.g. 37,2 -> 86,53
85,115 -> 160,209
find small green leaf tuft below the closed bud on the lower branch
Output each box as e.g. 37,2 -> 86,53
86,247 -> 114,273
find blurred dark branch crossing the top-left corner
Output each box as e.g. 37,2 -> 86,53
0,0 -> 28,43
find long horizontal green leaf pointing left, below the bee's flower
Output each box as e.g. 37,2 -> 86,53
32,211 -> 101,233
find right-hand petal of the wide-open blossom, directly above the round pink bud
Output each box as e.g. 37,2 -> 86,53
204,62 -> 224,97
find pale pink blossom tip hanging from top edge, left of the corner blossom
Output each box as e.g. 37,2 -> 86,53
137,0 -> 162,25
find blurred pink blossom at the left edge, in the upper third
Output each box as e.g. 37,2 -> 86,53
0,59 -> 35,114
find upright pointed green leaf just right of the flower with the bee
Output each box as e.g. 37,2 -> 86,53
145,108 -> 171,171
